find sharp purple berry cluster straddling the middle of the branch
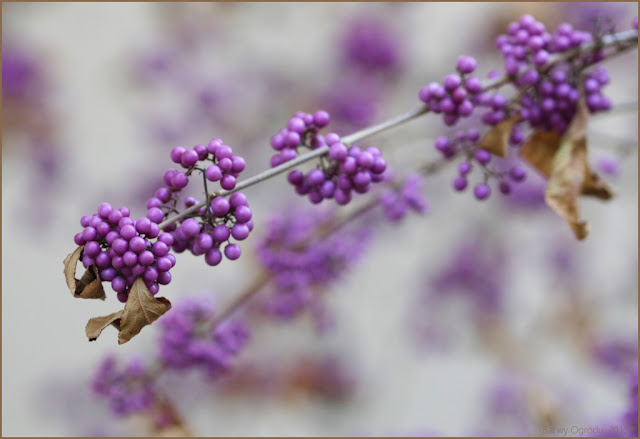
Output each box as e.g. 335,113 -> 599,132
271,111 -> 387,205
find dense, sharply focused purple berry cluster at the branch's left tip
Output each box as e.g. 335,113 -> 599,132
74,203 -> 176,302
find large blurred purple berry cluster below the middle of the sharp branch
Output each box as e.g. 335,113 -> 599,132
256,210 -> 371,318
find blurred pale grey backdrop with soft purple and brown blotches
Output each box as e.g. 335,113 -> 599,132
2,3 -> 638,436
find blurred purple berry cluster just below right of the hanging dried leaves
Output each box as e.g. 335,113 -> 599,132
159,297 -> 250,377
